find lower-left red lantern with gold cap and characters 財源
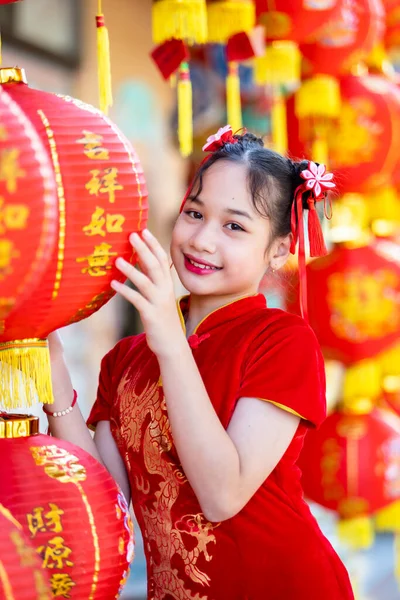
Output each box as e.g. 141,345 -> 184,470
0,414 -> 133,600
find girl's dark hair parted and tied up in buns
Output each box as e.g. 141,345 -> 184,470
190,133 -> 308,241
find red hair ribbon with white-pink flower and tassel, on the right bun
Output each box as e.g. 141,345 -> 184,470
290,161 -> 336,321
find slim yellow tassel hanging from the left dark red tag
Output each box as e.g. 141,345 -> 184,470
178,62 -> 193,157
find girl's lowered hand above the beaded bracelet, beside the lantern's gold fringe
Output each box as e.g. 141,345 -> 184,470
47,331 -> 74,408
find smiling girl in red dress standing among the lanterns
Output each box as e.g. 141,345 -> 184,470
46,128 -> 353,600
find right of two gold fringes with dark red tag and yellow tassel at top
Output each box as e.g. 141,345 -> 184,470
207,0 -> 256,132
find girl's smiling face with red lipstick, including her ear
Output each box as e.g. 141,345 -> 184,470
171,160 -> 290,300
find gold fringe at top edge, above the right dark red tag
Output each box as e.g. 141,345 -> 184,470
207,0 -> 256,44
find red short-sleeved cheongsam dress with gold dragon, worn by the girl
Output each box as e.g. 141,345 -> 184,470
88,294 -> 353,600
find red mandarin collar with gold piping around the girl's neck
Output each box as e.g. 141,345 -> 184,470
177,294 -> 267,337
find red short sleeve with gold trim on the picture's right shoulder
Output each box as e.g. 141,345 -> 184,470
239,324 -> 326,426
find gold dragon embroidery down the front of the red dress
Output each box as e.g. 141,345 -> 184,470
118,373 -> 216,600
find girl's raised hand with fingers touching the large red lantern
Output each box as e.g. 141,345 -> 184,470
111,229 -> 185,357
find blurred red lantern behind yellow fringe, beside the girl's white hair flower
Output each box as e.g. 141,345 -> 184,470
288,75 -> 400,194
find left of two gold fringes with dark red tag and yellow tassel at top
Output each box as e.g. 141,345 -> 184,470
152,0 -> 207,157
